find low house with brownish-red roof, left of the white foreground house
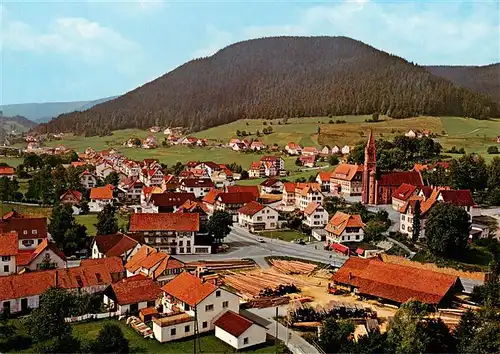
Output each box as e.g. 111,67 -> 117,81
104,275 -> 162,315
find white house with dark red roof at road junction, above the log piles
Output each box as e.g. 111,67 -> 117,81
238,201 -> 279,232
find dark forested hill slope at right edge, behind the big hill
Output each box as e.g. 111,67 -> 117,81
426,63 -> 500,102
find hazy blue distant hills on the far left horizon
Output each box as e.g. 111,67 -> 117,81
0,96 -> 118,123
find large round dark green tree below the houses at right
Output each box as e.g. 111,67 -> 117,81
425,203 -> 470,258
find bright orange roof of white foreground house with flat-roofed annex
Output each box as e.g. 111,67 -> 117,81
161,272 -> 217,306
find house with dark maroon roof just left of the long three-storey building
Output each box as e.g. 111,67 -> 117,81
91,232 -> 141,262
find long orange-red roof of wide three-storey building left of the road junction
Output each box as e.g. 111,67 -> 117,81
130,213 -> 200,232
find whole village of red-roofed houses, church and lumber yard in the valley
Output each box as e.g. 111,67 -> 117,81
0,127 -> 498,353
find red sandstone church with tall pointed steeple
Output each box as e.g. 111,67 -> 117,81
361,130 -> 424,205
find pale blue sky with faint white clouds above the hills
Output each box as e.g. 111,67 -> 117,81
0,0 -> 500,104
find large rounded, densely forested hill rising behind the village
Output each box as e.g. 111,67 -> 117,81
38,37 -> 498,135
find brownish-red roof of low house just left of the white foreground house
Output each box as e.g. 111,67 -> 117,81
111,276 -> 161,305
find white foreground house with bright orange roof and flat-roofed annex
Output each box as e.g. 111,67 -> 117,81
153,272 -> 239,342
